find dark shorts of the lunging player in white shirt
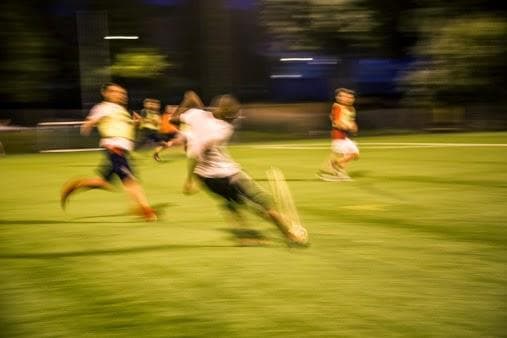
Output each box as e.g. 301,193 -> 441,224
197,172 -> 273,210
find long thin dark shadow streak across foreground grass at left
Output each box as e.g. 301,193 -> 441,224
0,244 -> 240,259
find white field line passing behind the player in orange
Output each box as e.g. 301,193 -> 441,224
250,142 -> 507,150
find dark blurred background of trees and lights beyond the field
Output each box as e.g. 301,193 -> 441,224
0,0 -> 507,150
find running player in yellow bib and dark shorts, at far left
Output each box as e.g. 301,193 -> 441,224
61,83 -> 157,221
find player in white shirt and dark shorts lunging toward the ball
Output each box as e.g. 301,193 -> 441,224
170,92 -> 308,245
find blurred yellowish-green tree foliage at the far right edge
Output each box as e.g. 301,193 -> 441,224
401,11 -> 507,104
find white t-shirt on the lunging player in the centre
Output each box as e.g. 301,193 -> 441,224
180,108 -> 241,177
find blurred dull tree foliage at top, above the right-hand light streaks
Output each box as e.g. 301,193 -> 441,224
261,0 -> 380,53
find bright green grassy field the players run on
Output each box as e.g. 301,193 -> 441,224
0,133 -> 507,337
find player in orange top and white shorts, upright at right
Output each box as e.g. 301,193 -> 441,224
318,88 -> 359,181
